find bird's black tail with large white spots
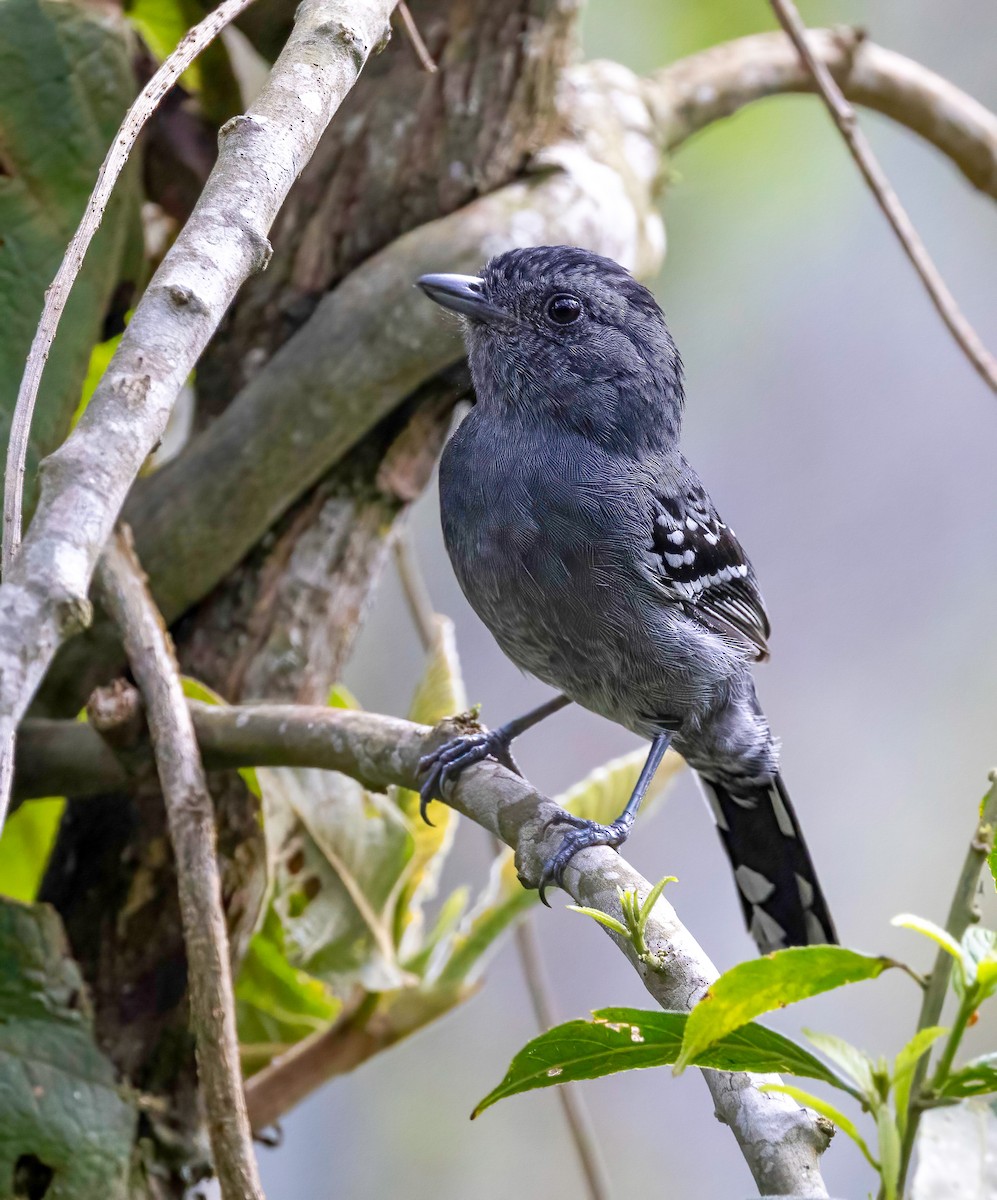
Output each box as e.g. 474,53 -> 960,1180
699,775 -> 837,954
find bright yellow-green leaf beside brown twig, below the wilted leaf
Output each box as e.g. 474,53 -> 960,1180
235,907 -> 342,1074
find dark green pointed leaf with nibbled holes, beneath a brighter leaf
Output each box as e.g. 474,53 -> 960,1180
472,1008 -> 837,1117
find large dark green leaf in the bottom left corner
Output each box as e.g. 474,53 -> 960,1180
0,900 -> 136,1200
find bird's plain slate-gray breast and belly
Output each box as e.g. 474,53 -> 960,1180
440,409 -> 700,732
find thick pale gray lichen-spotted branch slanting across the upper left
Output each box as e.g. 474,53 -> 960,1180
0,0 -> 394,824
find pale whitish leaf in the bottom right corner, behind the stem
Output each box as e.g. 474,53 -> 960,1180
912,1100 -> 997,1200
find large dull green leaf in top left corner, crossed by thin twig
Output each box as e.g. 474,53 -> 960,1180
0,0 -> 139,501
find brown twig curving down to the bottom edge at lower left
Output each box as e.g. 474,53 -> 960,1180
97,533 -> 264,1200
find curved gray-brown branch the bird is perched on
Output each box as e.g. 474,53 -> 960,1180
24,701 -> 829,1196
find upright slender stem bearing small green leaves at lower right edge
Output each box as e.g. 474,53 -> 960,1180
899,770 -> 997,1195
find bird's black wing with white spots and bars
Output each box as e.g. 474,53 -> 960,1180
653,478 -> 770,660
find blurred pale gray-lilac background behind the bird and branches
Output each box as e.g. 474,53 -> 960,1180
260,0 -> 997,1200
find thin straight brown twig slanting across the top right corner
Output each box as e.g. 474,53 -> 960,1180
770,0 -> 997,391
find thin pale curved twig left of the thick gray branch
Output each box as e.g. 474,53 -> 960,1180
2,0 -> 261,576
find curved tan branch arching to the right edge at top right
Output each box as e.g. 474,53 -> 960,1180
647,29 -> 997,199
